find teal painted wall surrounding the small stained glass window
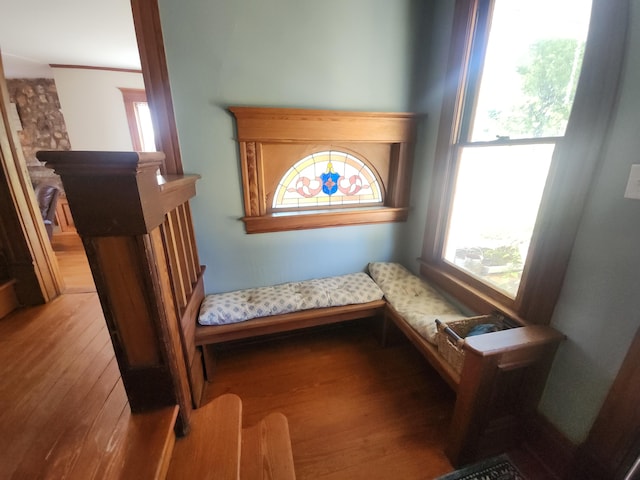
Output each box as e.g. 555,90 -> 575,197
159,0 -> 414,292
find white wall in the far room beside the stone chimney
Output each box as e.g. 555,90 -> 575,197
52,68 -> 144,151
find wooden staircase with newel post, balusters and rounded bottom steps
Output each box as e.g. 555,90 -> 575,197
37,151 -> 295,480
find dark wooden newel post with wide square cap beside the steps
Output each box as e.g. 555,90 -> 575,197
37,152 -> 198,434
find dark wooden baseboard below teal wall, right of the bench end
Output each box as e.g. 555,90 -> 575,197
523,412 -> 578,479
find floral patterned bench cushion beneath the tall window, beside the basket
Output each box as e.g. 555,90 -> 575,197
369,262 -> 466,344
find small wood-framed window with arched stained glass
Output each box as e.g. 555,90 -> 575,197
230,107 -> 415,233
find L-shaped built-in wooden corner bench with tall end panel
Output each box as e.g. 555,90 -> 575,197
194,264 -> 564,464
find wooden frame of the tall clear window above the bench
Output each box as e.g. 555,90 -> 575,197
420,0 -> 625,324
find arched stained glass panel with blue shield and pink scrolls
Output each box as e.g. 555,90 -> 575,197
273,151 -> 382,209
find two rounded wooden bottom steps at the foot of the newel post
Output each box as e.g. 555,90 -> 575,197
166,394 -> 295,480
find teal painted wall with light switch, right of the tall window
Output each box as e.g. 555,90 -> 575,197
540,0 -> 640,443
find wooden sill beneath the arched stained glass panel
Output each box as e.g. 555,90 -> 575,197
242,207 -> 409,233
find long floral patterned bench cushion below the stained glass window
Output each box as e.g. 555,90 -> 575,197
198,273 -> 383,325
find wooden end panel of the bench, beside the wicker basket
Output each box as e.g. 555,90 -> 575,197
446,326 -> 563,465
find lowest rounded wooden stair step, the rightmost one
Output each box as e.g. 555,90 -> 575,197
240,413 -> 296,480
